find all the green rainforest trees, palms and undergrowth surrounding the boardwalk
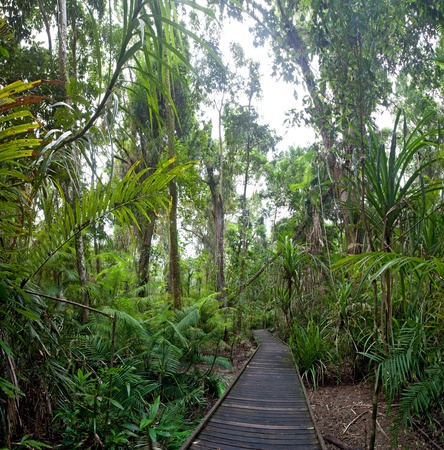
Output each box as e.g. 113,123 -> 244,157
0,0 -> 444,449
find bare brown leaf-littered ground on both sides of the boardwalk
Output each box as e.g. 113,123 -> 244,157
217,344 -> 440,450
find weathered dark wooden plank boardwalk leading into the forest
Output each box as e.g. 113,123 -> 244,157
181,330 -> 326,450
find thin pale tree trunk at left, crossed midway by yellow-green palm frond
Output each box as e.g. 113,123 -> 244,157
57,0 -> 89,322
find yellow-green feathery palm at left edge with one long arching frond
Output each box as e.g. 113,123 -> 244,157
0,82 -> 191,446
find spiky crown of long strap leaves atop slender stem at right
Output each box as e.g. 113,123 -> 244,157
349,111 -> 443,250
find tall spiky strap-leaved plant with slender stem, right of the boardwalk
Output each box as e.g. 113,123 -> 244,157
338,111 -> 442,341
